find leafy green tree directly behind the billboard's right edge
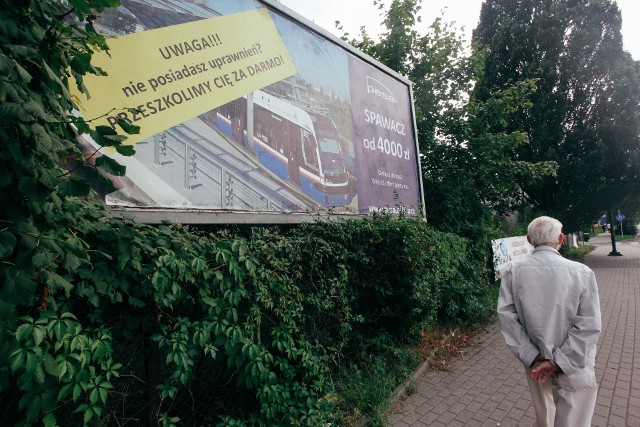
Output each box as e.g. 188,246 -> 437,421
340,0 -> 555,237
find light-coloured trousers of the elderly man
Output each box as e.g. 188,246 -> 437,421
525,366 -> 598,427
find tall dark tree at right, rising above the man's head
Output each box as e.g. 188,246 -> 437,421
474,0 -> 640,230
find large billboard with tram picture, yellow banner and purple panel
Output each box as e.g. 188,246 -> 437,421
73,0 -> 423,223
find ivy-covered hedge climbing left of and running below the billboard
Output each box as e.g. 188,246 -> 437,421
0,0 -> 491,426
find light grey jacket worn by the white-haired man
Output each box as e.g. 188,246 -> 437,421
498,246 -> 601,375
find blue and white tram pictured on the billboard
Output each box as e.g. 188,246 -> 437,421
207,90 -> 353,207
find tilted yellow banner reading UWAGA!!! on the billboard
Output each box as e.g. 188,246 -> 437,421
72,8 -> 296,143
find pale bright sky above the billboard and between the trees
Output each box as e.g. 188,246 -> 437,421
280,0 -> 640,60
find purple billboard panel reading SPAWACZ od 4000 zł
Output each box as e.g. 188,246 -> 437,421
349,56 -> 420,215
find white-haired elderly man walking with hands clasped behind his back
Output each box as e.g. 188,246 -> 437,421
498,216 -> 600,426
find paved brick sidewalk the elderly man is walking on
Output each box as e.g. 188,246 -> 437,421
388,233 -> 640,427
